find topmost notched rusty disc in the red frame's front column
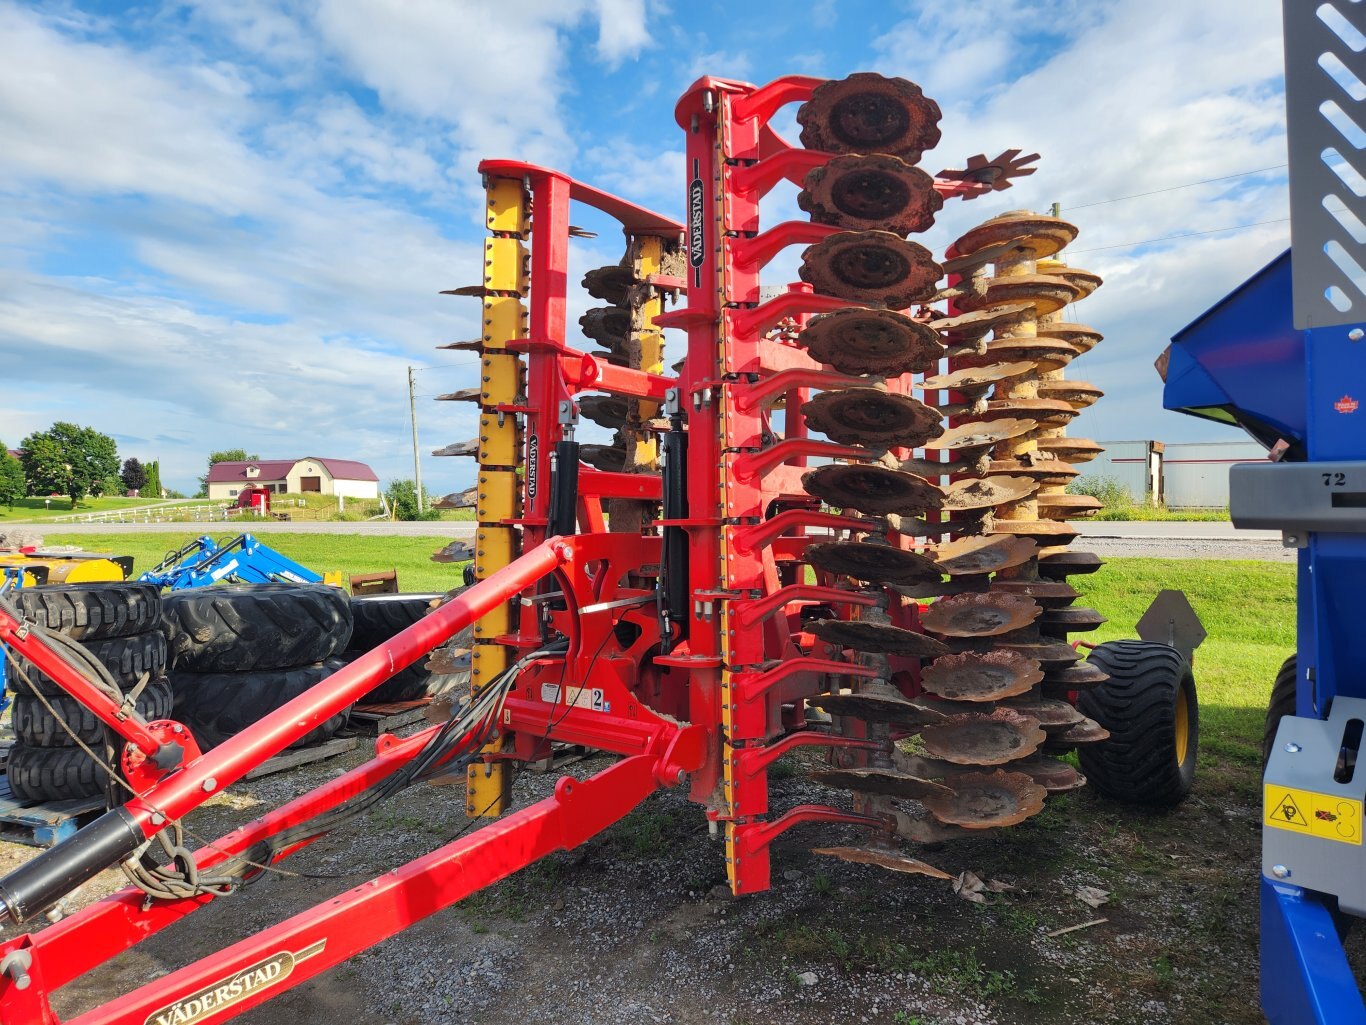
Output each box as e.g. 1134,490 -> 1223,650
796,71 -> 940,164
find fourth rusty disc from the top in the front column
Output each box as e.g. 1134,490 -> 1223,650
796,309 -> 944,377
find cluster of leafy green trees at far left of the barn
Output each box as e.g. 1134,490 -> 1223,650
0,421 -> 164,508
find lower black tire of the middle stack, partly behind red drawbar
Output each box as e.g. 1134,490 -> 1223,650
169,659 -> 351,750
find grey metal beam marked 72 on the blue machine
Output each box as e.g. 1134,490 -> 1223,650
1228,461 -> 1366,534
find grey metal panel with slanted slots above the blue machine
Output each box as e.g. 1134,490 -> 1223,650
1281,0 -> 1366,331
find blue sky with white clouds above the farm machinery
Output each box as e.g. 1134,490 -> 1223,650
0,0 -> 1288,493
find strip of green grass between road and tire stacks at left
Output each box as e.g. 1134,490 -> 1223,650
44,533 -> 462,592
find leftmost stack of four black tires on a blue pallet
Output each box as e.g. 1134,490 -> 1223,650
7,584 -> 173,801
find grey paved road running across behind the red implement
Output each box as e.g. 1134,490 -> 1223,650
33,521 -> 1295,563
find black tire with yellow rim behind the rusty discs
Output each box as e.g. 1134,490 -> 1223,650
1076,641 -> 1199,808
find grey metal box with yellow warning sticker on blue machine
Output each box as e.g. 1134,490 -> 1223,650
1262,697 -> 1366,914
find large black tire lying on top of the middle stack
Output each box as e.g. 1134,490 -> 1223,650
163,584 -> 351,672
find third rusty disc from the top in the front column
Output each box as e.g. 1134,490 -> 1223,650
799,231 -> 943,309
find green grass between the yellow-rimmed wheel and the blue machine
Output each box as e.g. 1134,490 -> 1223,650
1071,559 -> 1295,765
